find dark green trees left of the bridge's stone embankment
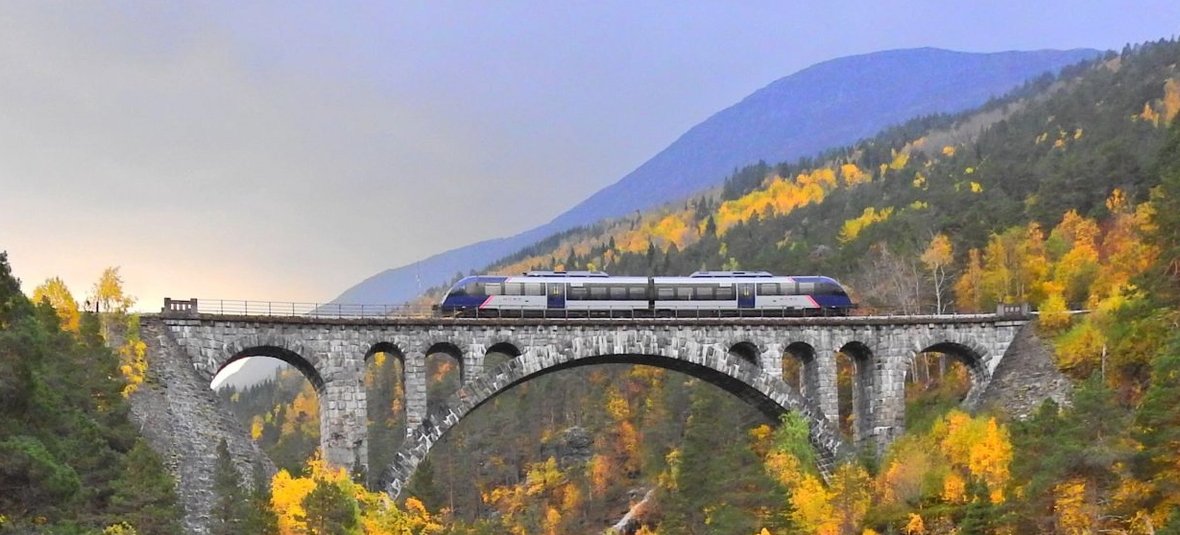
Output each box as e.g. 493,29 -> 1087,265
0,253 -> 179,534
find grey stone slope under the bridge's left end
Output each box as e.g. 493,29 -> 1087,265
130,321 -> 275,534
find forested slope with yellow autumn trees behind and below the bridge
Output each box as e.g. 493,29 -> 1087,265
219,41 -> 1180,535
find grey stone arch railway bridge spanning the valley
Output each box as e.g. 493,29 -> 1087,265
152,308 -> 1028,496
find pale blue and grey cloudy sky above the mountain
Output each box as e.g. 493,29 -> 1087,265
0,0 -> 1180,312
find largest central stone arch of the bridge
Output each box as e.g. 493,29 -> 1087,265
380,346 -> 844,496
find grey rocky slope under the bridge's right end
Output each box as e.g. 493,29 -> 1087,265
981,325 -> 1074,419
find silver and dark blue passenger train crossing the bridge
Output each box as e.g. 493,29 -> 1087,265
435,272 -> 856,318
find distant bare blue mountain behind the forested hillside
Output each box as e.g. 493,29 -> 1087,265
334,48 -> 1099,304
